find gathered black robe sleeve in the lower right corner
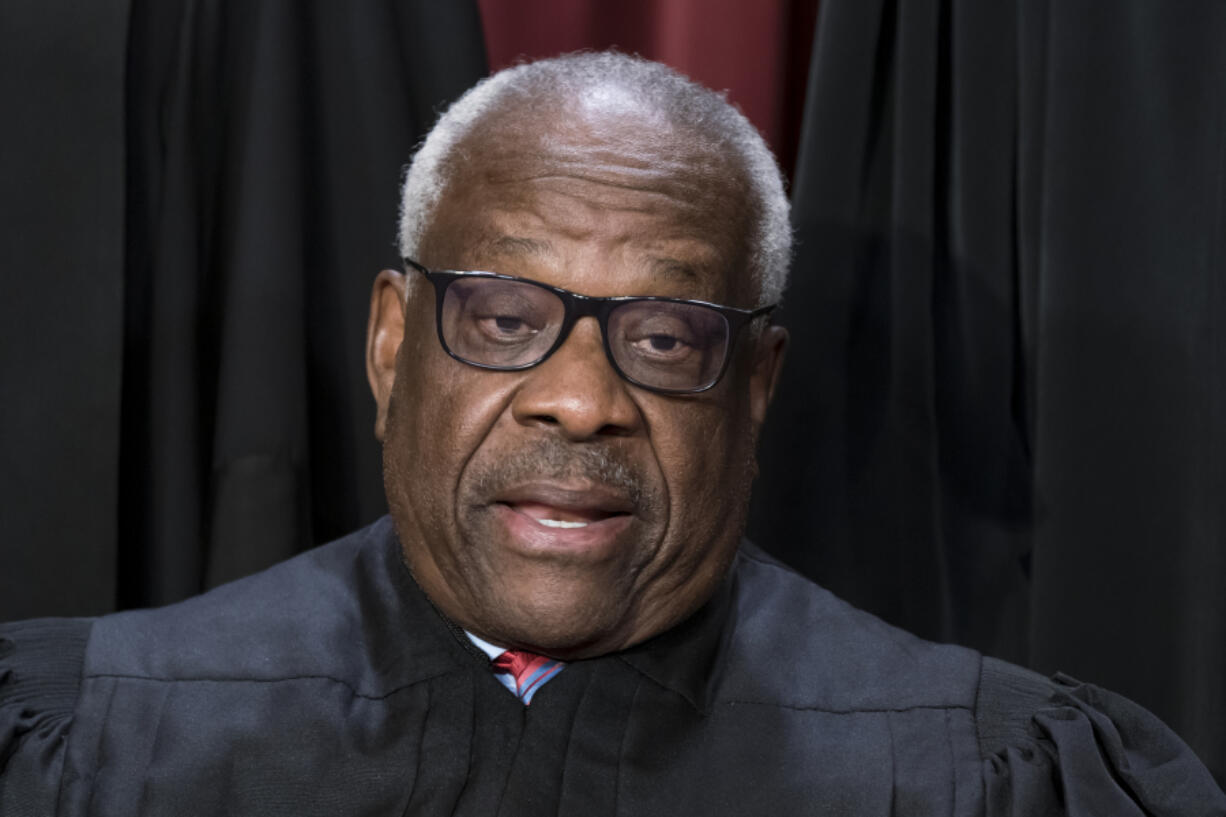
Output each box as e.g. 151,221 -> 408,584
976,659 -> 1226,817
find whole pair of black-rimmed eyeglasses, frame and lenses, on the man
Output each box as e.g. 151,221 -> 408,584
403,258 -> 775,394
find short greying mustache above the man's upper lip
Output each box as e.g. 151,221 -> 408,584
472,437 -> 656,508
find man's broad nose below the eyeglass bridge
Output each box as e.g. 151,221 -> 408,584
511,318 -> 642,442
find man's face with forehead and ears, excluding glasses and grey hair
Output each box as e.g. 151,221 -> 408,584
368,99 -> 786,659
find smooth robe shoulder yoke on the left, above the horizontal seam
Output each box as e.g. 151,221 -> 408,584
76,518 -> 434,697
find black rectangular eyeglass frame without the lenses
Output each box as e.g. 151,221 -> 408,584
401,258 -> 779,395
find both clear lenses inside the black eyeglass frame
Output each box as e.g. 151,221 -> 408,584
441,277 -> 728,391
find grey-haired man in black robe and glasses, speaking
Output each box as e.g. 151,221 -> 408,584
0,54 -> 1226,815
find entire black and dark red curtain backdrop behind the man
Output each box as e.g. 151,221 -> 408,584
0,0 -> 1226,780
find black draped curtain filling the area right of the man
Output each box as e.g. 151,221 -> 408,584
753,0 -> 1226,780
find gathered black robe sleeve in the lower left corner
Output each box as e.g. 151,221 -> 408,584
0,618 -> 92,817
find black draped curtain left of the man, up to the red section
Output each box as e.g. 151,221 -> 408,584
0,0 -> 484,610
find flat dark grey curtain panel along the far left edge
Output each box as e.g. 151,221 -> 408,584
0,0 -> 129,618
